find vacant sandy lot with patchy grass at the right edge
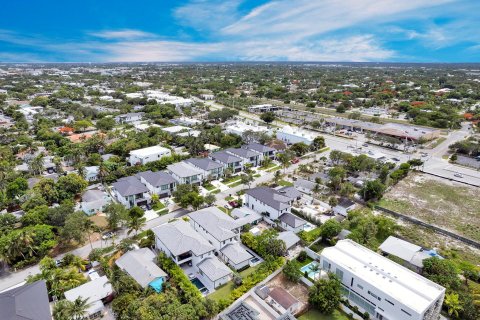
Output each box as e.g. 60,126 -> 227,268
380,173 -> 480,240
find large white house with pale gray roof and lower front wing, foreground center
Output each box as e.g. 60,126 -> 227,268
152,220 -> 232,288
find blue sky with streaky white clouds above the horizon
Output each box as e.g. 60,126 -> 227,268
0,0 -> 480,62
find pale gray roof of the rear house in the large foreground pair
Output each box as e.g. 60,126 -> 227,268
188,207 -> 239,241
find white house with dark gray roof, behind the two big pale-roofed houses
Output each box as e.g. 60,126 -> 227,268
244,187 -> 294,220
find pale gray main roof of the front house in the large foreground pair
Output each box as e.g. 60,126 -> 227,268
152,220 -> 215,256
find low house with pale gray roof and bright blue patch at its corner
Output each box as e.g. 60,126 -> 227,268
115,248 -> 167,292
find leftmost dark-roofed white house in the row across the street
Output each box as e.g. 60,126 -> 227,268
112,176 -> 151,209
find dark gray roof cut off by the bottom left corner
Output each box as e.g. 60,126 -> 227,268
0,280 -> 52,320
